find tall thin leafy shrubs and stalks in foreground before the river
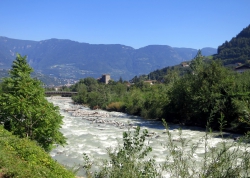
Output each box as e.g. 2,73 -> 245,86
84,122 -> 250,178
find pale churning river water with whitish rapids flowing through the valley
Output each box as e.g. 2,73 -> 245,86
47,97 -> 240,176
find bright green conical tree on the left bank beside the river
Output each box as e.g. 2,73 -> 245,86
0,54 -> 66,151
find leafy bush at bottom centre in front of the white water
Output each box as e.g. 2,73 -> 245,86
84,127 -> 159,178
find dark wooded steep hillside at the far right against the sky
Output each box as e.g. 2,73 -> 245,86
215,25 -> 250,64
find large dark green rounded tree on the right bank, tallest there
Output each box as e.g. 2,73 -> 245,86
167,52 -> 246,129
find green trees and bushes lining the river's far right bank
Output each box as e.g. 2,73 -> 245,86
70,51 -> 250,133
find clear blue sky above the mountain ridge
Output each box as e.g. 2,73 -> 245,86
0,0 -> 250,49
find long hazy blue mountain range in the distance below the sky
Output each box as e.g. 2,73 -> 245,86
0,37 -> 216,80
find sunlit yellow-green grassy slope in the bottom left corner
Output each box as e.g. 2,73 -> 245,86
0,126 -> 75,178
